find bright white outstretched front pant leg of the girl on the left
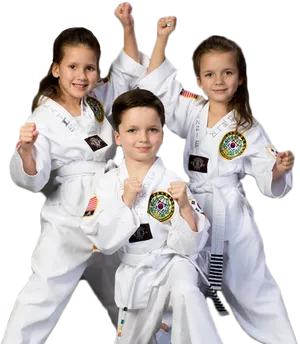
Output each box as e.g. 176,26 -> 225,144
2,205 -> 92,344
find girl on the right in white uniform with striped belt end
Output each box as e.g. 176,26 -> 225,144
138,16 -> 296,344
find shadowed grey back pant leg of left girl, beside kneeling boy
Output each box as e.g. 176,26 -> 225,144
83,252 -> 120,329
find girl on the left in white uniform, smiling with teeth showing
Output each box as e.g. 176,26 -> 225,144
2,3 -> 150,344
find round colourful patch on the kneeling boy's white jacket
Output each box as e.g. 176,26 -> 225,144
148,191 -> 175,222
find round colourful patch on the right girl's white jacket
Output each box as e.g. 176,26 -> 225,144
219,131 -> 247,160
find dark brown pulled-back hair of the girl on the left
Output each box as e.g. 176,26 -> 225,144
30,27 -> 101,113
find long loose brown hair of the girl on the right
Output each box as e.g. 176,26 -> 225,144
193,34 -> 256,130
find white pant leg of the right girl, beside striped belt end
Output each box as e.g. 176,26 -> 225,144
223,216 -> 296,344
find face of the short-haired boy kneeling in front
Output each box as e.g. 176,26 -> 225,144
115,107 -> 165,163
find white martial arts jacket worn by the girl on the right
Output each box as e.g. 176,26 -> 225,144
137,59 -> 292,245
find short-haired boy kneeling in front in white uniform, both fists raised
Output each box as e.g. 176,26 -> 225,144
82,89 -> 222,344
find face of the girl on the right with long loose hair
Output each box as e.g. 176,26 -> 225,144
196,51 -> 242,104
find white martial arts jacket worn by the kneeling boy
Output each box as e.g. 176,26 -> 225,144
82,158 -> 209,309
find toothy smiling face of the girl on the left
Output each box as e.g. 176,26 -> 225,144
52,44 -> 99,101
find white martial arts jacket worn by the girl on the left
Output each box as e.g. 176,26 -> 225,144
10,50 -> 148,216
